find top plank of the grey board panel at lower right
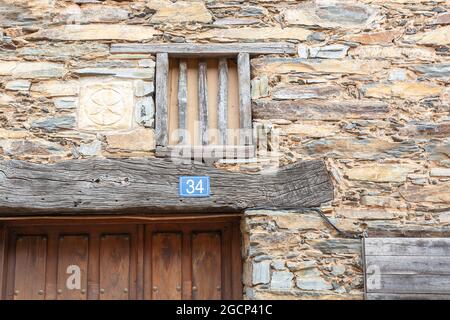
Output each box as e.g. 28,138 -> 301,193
365,238 -> 450,256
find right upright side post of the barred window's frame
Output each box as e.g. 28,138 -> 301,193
238,53 -> 253,145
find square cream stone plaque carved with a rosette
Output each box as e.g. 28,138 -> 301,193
78,81 -> 134,131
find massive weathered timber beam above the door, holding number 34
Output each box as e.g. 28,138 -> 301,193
0,158 -> 333,216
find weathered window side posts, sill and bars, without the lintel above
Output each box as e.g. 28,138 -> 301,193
155,52 -> 255,159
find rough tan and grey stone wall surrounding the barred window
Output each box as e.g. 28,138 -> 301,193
0,0 -> 450,299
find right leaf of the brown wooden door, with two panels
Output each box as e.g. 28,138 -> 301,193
144,222 -> 242,300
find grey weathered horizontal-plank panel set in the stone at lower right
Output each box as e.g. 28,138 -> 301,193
364,238 -> 450,300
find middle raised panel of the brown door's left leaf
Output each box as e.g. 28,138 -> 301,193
57,235 -> 89,300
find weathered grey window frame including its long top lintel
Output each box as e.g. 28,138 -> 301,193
121,42 -> 296,159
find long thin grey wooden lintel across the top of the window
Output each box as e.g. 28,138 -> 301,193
111,42 -> 297,57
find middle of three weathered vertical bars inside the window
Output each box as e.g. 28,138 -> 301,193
198,62 -> 209,145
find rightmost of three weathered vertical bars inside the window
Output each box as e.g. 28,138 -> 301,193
217,58 -> 228,145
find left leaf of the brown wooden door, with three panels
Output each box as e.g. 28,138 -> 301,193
6,226 -> 137,300
